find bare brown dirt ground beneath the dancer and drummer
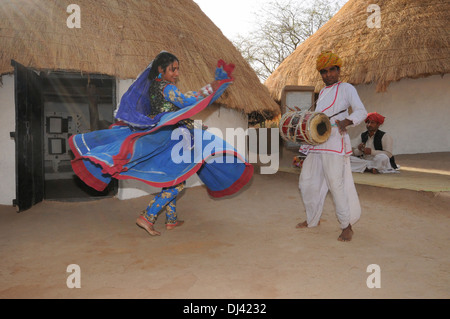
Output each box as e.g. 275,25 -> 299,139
0,153 -> 450,299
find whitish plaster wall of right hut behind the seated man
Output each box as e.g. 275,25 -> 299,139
349,74 -> 450,155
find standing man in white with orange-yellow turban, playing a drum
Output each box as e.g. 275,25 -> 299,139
296,51 -> 367,241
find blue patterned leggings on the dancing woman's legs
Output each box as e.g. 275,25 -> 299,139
143,182 -> 185,224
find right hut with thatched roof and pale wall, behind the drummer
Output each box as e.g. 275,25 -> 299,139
265,0 -> 450,154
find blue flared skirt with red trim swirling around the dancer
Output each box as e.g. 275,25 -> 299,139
69,79 -> 253,197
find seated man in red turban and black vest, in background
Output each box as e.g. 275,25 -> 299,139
350,112 -> 397,174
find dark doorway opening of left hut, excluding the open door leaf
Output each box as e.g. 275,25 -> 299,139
41,72 -> 117,201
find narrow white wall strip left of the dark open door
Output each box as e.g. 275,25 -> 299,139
0,75 -> 16,205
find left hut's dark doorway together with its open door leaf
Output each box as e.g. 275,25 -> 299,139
12,61 -> 117,212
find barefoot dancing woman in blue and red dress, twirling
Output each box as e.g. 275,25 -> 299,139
69,52 -> 253,235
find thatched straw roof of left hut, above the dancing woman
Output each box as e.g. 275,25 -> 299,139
0,0 -> 279,114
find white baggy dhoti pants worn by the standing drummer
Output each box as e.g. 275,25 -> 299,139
299,153 -> 361,229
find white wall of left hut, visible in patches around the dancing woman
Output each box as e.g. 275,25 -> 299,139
116,80 -> 248,200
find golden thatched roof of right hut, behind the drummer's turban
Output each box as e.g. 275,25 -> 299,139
265,0 -> 450,100
